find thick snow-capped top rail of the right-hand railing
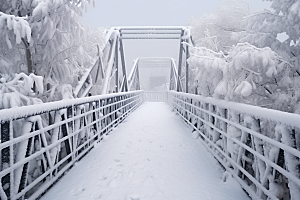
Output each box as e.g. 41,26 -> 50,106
168,91 -> 300,128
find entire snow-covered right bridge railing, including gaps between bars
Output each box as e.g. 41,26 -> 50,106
168,91 -> 300,200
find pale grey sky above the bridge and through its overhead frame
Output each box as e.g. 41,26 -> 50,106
82,0 -> 270,76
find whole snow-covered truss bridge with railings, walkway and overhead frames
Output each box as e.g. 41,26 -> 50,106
0,27 -> 300,200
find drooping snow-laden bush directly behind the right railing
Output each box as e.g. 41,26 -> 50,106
189,43 -> 300,112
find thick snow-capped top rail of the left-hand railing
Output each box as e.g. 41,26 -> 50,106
0,90 -> 142,123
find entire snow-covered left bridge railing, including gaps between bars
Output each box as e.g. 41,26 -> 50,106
0,91 -> 144,200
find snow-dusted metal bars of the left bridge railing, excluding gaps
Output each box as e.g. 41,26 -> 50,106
0,91 -> 144,200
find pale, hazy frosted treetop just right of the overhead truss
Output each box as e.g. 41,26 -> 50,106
189,0 -> 249,52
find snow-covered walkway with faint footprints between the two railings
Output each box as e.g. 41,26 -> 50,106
41,103 -> 249,200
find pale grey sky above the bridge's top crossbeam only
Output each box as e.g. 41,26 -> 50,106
83,0 -> 270,27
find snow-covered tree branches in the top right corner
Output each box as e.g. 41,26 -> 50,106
232,0 -> 300,59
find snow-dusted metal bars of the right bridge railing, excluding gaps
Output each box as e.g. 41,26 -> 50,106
168,91 -> 300,199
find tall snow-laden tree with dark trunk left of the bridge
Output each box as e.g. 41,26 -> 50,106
0,0 -> 96,103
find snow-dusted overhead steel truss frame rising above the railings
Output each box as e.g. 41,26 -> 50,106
82,26 -> 192,97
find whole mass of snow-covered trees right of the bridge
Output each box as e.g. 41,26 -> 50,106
190,0 -> 300,113
